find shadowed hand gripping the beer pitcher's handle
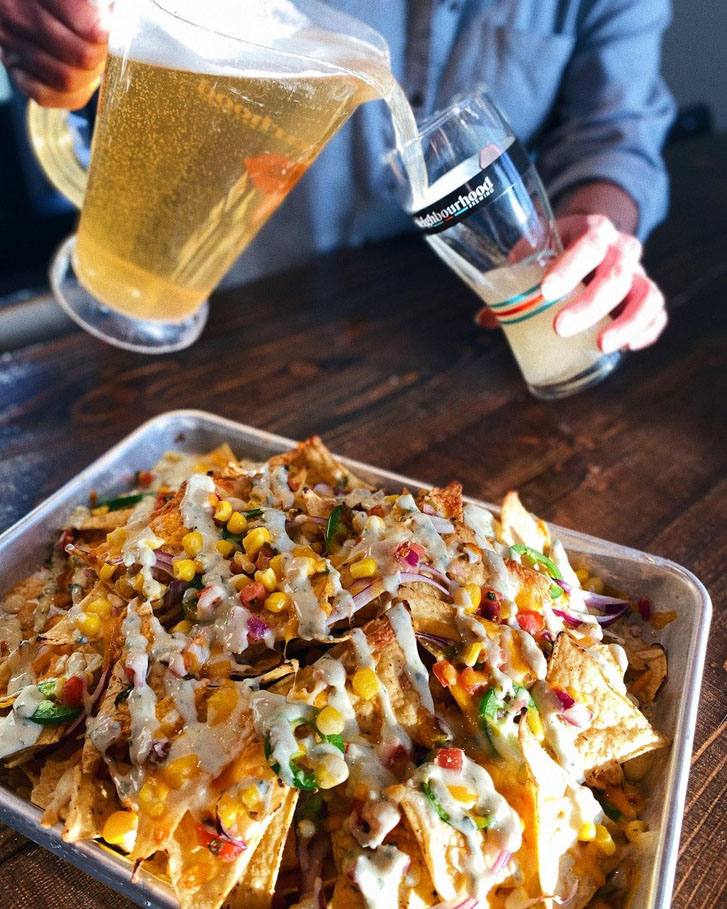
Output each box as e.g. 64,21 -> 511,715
0,0 -> 110,110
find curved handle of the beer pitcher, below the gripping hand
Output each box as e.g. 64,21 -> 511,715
26,101 -> 88,209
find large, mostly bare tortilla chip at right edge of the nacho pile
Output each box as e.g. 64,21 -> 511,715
546,632 -> 669,776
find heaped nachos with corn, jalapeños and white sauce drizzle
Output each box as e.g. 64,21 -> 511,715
0,438 -> 668,909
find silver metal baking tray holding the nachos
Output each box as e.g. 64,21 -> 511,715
0,410 -> 712,909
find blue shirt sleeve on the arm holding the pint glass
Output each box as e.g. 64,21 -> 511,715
538,0 -> 674,239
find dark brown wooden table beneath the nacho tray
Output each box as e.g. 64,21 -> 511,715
0,136 -> 727,909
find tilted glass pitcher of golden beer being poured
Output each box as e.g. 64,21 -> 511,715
28,0 -> 393,353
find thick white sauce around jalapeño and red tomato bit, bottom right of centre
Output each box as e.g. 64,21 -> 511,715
408,754 -> 522,900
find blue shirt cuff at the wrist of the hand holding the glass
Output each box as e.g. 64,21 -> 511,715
545,149 -> 669,240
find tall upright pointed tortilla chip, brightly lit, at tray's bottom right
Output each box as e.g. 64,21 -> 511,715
518,723 -> 605,909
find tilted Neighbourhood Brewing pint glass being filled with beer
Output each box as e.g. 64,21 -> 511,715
389,89 -> 621,398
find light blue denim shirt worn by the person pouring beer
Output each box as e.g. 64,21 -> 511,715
226,0 -> 673,283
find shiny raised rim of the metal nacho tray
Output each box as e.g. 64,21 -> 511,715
0,408 -> 712,909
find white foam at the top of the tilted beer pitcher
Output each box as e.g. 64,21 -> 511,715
109,0 -> 388,78
